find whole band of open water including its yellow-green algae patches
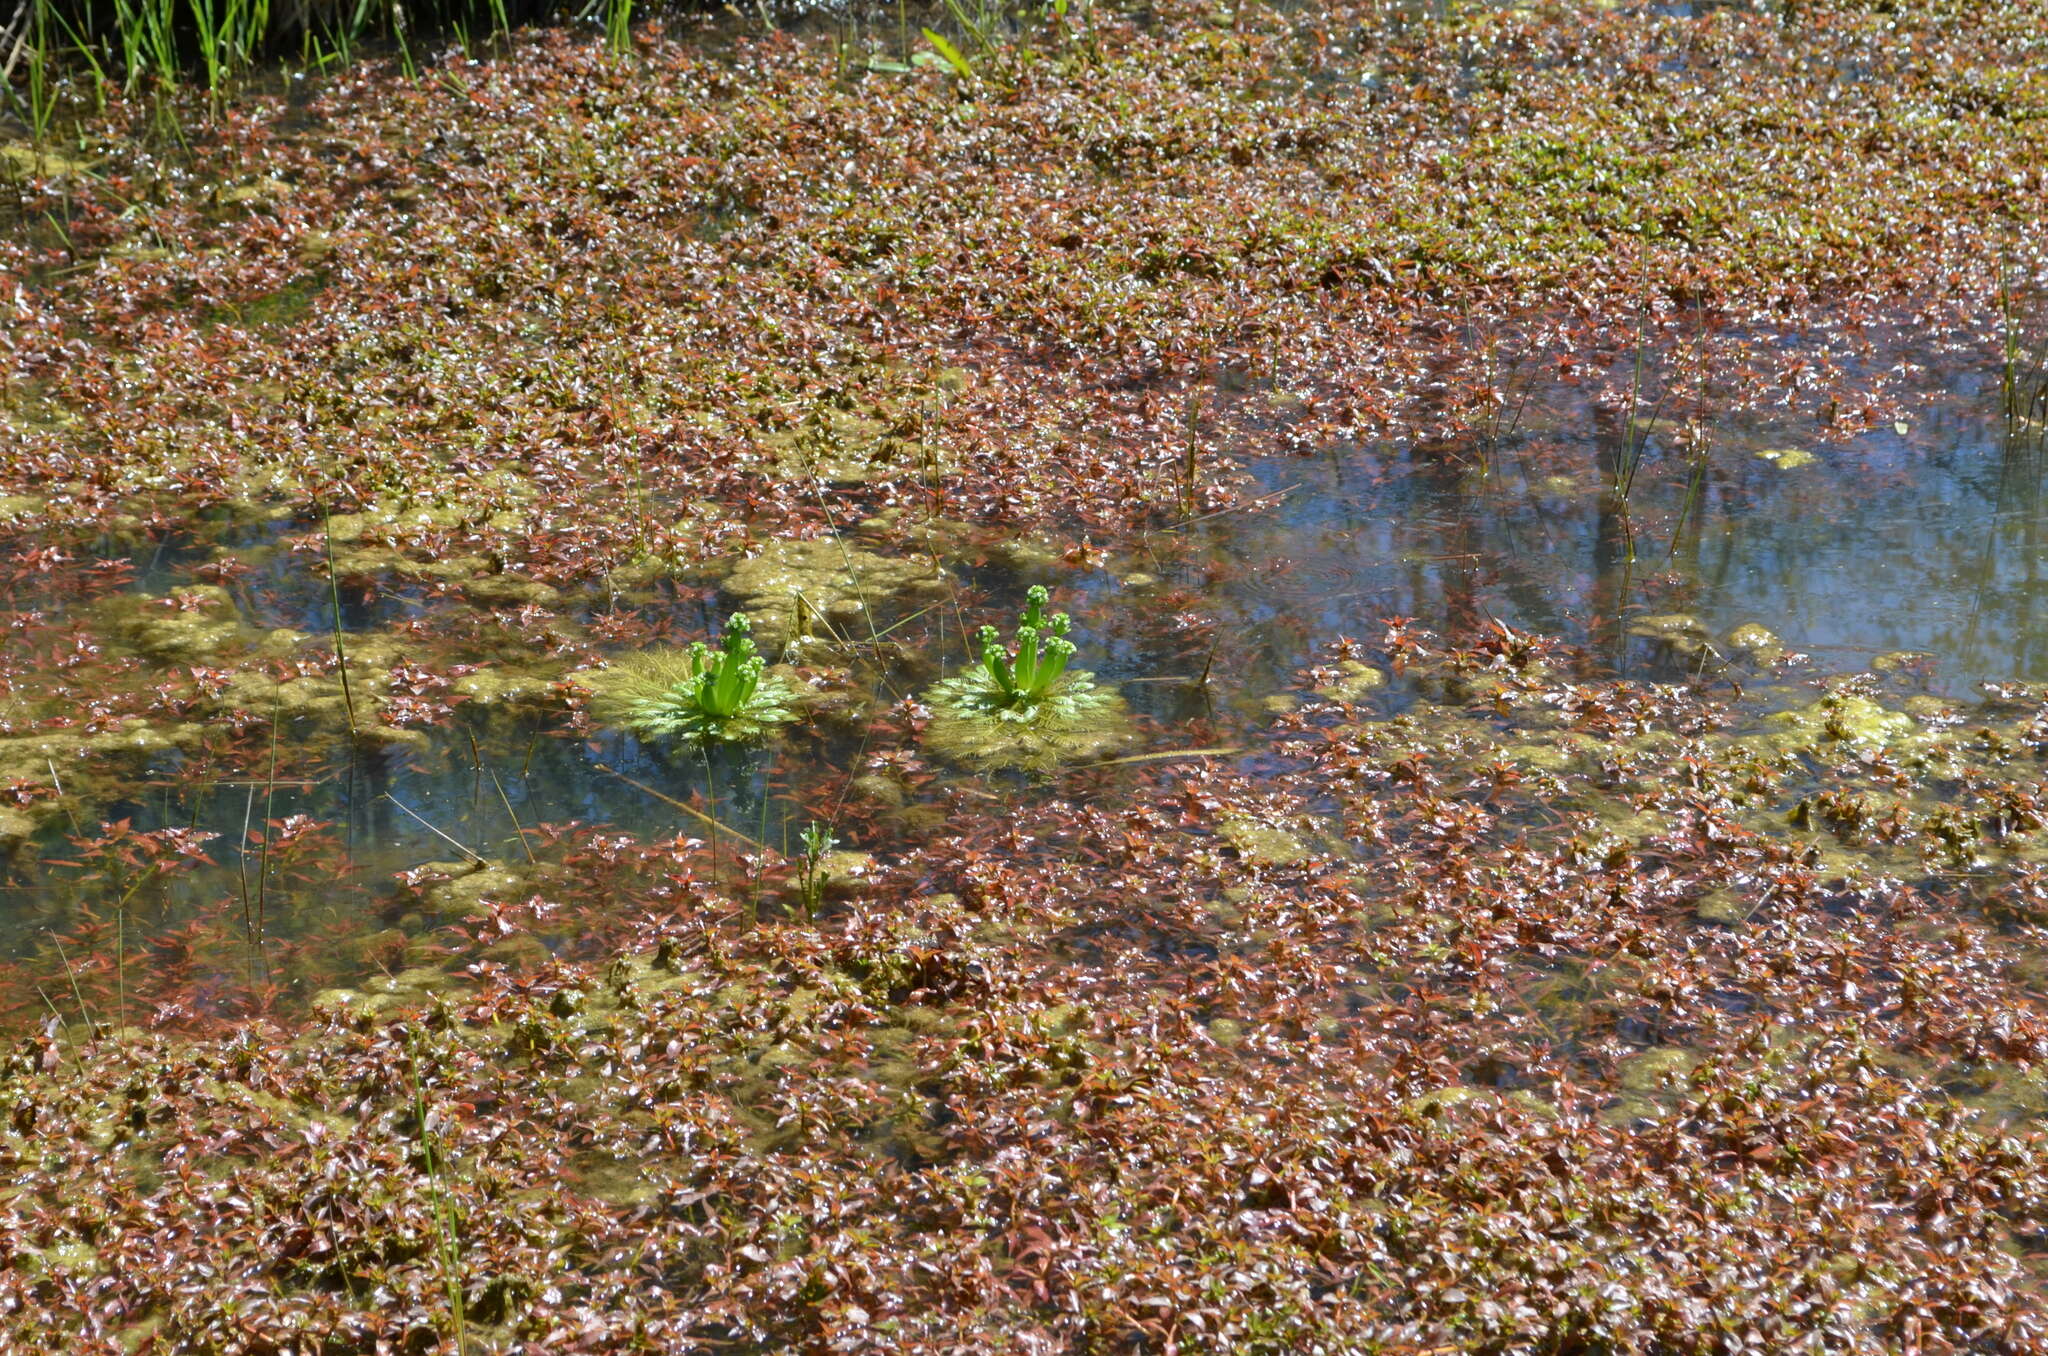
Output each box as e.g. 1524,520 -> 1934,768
0,329 -> 2048,1024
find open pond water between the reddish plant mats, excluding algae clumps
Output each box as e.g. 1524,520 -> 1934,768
0,329 -> 2048,1007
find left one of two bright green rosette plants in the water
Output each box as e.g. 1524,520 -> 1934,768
588,615 -> 797,744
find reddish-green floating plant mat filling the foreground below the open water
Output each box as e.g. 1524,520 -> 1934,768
0,629 -> 2048,1352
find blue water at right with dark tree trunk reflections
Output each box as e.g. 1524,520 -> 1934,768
1200,366 -> 2048,694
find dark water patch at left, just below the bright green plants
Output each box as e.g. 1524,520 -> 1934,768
0,721 -> 844,973
